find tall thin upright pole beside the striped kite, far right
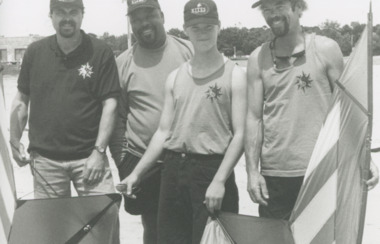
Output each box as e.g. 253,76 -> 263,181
357,1 -> 373,244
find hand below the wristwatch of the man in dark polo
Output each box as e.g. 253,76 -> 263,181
83,150 -> 106,186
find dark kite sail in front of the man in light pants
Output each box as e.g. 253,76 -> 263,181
9,194 -> 121,244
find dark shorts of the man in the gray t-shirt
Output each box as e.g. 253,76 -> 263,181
118,152 -> 162,215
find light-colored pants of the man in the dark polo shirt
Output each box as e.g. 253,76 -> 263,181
31,152 -> 115,199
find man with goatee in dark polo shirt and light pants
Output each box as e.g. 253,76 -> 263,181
10,0 -> 120,202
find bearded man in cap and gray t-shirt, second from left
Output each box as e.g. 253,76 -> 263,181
110,0 -> 193,244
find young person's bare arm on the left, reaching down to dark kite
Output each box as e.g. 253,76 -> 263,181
116,70 -> 177,198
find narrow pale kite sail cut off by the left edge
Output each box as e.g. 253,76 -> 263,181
0,67 -> 16,243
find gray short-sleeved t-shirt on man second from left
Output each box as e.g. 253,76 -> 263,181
116,35 -> 193,155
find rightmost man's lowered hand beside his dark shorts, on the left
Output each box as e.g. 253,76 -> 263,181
247,171 -> 269,206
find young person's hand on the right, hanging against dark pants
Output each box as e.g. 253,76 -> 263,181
204,180 -> 226,214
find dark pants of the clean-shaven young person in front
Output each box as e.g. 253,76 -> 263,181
158,152 -> 239,244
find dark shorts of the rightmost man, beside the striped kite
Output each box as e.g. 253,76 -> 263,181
259,176 -> 304,220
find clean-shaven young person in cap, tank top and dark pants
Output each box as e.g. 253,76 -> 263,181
118,0 -> 246,244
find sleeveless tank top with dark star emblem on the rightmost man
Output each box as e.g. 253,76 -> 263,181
259,34 -> 333,177
